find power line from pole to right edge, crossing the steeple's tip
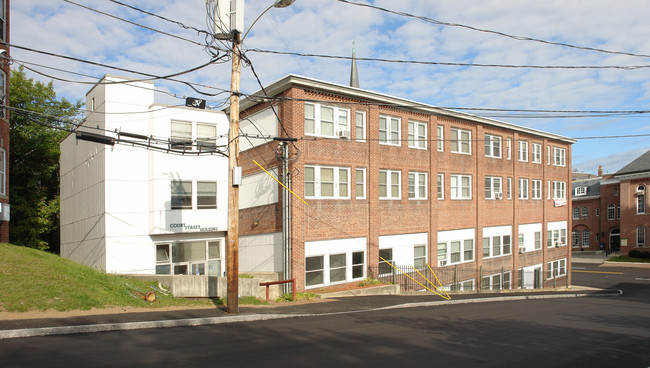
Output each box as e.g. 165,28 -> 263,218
246,47 -> 650,70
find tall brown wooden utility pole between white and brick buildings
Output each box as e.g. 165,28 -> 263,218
226,31 -> 241,313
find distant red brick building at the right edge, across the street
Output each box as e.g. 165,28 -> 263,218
572,151 -> 650,254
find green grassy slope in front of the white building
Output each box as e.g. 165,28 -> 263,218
0,244 -> 212,312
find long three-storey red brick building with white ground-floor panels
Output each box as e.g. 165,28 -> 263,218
233,75 -> 575,290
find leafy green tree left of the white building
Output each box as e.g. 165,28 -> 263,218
9,67 -> 82,253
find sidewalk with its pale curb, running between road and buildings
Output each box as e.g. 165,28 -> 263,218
0,286 -> 621,340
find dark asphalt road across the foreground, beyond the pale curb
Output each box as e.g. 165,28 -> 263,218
0,264 -> 650,368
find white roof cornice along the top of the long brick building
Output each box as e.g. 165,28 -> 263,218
230,74 -> 577,144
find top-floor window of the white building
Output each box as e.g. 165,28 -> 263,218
170,120 -> 217,151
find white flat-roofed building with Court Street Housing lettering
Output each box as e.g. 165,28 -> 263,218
60,76 -> 228,276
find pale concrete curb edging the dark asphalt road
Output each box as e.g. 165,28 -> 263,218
0,290 -> 623,340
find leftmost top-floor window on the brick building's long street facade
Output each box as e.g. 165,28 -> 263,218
305,103 -> 350,138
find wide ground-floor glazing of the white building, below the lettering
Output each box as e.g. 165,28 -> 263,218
156,239 -> 223,276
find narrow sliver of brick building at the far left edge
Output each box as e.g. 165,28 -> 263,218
0,0 -> 11,243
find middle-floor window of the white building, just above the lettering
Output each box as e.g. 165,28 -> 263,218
170,180 -> 217,210
